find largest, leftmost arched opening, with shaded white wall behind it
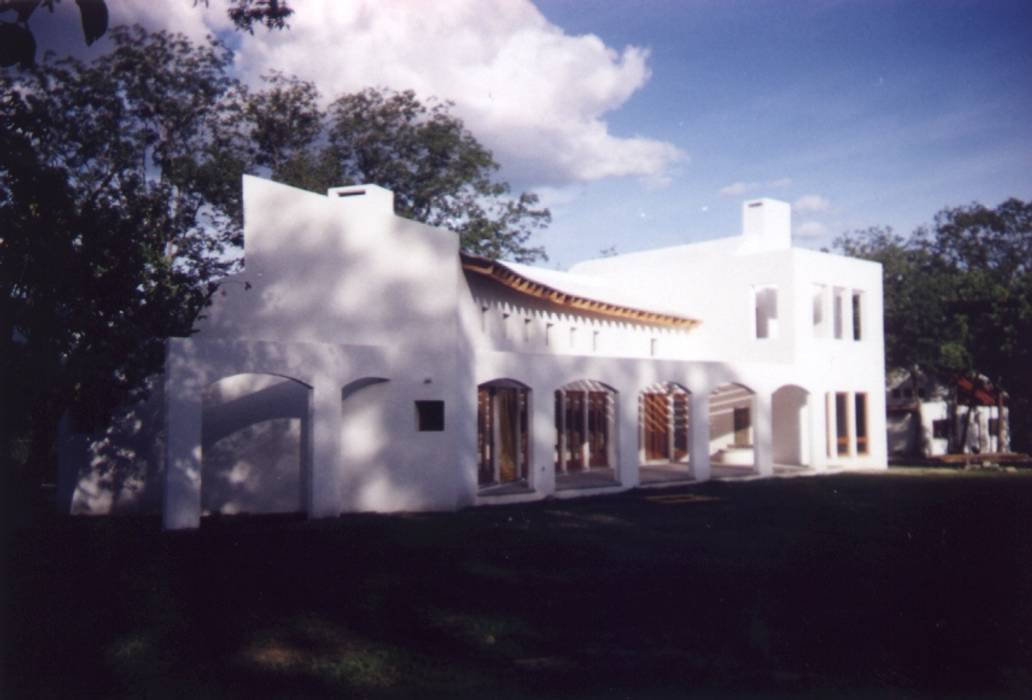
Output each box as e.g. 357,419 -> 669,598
201,374 -> 312,514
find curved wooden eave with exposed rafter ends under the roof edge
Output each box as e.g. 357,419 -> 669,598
459,253 -> 699,330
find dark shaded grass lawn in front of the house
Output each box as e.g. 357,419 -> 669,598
0,470 -> 1032,699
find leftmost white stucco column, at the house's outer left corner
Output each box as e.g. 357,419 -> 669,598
161,339 -> 203,530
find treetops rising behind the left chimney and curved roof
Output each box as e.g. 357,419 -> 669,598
243,74 -> 551,262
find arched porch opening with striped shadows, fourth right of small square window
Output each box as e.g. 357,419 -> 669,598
709,384 -> 757,477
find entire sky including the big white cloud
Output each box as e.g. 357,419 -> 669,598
24,0 -> 1032,267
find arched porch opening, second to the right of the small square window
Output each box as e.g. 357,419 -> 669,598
555,379 -> 616,488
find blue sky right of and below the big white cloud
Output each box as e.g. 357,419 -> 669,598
538,0 -> 1032,264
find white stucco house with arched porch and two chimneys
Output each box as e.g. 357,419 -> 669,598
59,177 -> 886,529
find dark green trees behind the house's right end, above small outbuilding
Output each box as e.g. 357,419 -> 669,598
835,199 -> 1032,449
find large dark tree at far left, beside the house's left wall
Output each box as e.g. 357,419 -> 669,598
0,28 -> 245,485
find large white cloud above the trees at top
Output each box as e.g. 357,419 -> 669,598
113,0 -> 683,185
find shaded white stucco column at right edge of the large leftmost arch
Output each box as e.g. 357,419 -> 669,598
305,379 -> 343,517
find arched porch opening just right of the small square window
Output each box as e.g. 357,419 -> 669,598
477,379 -> 530,492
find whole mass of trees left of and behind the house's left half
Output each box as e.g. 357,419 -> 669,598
0,24 -> 550,491
